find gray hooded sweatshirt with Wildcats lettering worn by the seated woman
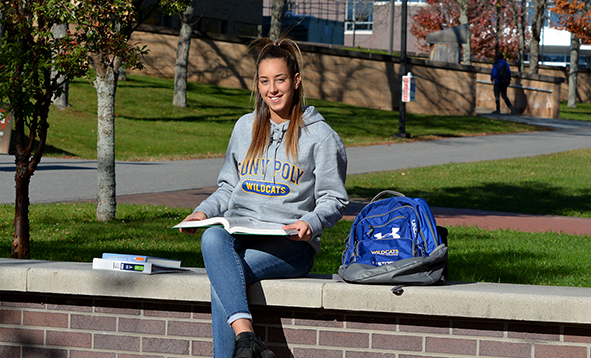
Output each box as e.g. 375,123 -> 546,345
195,106 -> 349,252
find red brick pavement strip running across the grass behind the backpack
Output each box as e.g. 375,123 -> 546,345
117,188 -> 591,235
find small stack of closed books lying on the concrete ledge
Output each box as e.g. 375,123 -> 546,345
92,253 -> 188,275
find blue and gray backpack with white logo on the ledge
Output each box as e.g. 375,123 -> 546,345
339,190 -> 447,293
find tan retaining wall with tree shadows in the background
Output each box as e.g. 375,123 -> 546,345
132,28 -> 564,118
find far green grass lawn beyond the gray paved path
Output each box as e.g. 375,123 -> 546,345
44,75 -> 535,160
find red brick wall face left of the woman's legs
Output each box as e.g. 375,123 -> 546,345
0,293 -> 213,358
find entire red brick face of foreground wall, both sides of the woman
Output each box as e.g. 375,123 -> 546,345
0,292 -> 591,358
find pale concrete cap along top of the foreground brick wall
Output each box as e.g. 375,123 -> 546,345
0,259 -> 591,324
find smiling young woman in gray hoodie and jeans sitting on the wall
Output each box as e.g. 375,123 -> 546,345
181,39 -> 348,358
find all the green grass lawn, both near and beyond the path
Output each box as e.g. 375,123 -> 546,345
0,76 -> 591,287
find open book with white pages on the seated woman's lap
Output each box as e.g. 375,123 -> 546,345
173,216 -> 298,236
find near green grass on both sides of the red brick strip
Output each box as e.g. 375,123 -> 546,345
0,149 -> 591,287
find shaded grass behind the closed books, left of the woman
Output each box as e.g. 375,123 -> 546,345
0,203 -> 204,267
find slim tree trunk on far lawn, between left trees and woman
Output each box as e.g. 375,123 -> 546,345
172,6 -> 193,107
